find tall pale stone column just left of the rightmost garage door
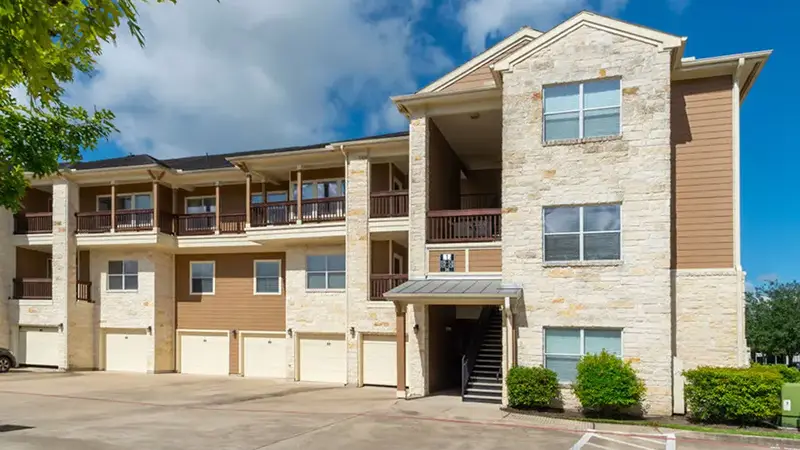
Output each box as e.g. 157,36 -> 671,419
345,152 -> 370,385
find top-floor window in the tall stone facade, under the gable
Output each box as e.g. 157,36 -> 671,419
544,79 -> 622,142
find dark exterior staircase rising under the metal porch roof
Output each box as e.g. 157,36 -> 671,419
461,308 -> 503,404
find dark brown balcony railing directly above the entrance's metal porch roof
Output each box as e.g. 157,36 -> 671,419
428,209 -> 501,243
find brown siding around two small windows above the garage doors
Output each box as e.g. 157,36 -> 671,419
175,253 -> 286,373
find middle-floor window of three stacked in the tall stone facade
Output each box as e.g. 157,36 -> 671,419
544,205 -> 621,262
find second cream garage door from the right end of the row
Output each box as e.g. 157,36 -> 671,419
299,336 -> 347,383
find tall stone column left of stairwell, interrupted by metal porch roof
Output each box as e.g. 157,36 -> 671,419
406,116 -> 430,397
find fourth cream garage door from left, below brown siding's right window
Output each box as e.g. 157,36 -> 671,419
242,333 -> 286,378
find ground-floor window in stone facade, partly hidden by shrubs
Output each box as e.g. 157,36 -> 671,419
544,328 -> 622,383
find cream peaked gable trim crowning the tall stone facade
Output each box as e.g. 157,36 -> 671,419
492,11 -> 684,72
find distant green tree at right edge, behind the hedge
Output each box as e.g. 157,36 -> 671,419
745,281 -> 800,356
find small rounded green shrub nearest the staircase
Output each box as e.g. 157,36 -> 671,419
506,367 -> 561,409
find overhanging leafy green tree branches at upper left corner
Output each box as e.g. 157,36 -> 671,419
0,0 -> 175,210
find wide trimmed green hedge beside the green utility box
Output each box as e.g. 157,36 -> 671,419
683,366 -> 784,424
